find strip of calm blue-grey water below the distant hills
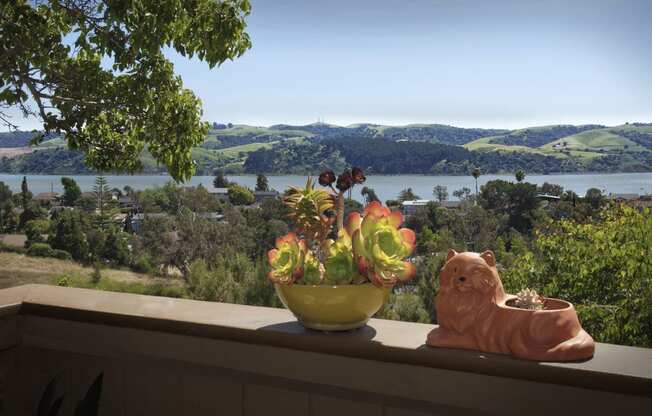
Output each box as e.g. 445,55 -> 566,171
0,173 -> 652,201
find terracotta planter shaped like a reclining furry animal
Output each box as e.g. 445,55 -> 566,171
427,250 -> 595,361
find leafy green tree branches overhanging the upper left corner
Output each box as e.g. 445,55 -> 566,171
0,0 -> 251,180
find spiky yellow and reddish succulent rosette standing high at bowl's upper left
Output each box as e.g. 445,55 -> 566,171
284,178 -> 335,241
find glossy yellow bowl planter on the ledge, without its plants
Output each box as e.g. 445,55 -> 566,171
274,283 -> 390,331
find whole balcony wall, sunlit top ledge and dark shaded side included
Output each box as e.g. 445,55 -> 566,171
0,285 -> 652,416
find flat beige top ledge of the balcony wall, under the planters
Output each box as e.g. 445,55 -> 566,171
0,285 -> 652,398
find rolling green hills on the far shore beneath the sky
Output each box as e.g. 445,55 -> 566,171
0,123 -> 652,175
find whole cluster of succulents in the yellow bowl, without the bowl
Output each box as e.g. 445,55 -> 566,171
268,171 -> 416,287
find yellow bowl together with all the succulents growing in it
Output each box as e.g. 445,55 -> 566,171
268,168 -> 416,331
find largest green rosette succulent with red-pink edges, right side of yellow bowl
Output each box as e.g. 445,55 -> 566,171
347,201 -> 416,286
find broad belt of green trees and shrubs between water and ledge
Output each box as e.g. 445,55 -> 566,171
0,174 -> 652,347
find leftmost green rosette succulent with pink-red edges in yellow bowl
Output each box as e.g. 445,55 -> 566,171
267,233 -> 312,284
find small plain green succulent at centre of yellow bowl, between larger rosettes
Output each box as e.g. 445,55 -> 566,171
324,229 -> 360,285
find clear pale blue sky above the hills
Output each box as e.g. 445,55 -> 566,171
5,0 -> 652,128
